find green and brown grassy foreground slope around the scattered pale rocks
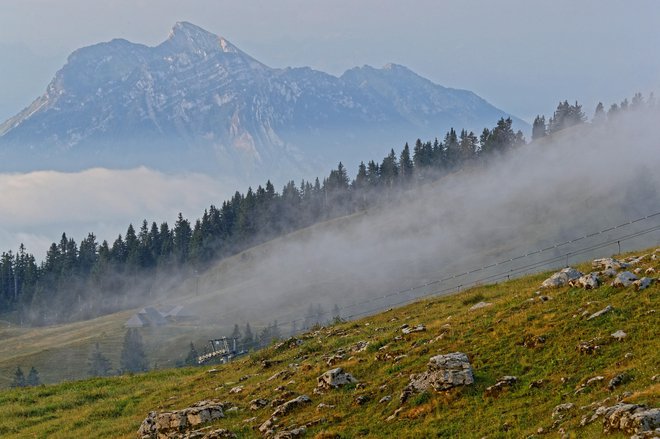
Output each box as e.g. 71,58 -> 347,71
0,249 -> 660,438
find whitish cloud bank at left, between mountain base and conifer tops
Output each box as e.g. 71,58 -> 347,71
0,167 -> 234,261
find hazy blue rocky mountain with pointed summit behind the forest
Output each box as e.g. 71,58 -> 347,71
0,22 -> 526,178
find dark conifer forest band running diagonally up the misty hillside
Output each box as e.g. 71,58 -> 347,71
0,93 -> 656,325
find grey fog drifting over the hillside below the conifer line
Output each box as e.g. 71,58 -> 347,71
179,107 -> 660,335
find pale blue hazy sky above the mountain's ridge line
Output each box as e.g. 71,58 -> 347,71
0,0 -> 660,124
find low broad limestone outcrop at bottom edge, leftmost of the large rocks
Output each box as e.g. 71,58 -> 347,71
137,401 -> 225,439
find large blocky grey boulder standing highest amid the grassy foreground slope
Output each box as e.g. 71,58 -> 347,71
401,352 -> 474,402
